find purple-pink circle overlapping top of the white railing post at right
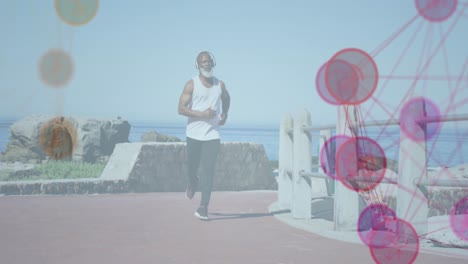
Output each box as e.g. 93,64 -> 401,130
399,97 -> 441,142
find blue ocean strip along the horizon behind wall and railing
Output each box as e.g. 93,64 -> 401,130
0,120 -> 468,167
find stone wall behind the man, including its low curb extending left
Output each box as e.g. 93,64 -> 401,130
0,142 -> 277,195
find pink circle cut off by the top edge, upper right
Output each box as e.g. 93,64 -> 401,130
415,0 -> 458,22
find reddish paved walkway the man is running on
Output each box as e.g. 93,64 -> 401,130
0,192 -> 467,264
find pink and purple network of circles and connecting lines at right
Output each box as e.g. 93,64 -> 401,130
316,0 -> 468,264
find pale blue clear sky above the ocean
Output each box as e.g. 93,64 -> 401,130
0,0 -> 468,126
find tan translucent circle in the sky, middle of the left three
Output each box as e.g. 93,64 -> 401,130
39,49 -> 73,88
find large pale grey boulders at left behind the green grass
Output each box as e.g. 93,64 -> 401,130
2,115 -> 130,162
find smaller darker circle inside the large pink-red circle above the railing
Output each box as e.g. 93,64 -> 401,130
325,59 -> 359,104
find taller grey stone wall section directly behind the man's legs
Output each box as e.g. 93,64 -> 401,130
129,143 -> 276,191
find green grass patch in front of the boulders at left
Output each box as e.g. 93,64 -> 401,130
0,161 -> 106,181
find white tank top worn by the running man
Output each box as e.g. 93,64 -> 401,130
185,76 -> 221,141
